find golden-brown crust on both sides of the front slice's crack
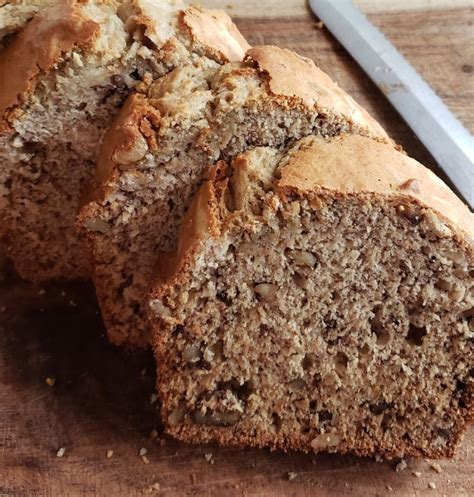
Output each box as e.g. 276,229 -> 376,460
151,135 -> 474,298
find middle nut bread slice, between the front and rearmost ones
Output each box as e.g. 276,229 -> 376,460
79,46 -> 388,346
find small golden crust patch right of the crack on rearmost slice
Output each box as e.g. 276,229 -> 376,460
181,7 -> 250,62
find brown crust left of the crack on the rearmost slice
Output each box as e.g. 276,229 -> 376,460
0,0 -> 100,132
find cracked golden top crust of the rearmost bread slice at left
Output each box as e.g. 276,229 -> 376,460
0,0 -> 249,132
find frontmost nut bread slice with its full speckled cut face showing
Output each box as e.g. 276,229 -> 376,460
151,136 -> 474,458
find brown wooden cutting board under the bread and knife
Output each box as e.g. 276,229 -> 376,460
0,0 -> 474,497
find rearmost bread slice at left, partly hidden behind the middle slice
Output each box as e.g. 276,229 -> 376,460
0,0 -> 248,281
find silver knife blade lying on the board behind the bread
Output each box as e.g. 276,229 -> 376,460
309,0 -> 474,209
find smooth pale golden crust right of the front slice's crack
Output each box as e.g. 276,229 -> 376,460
278,135 -> 474,242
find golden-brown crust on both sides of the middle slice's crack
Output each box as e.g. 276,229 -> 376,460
83,46 -> 393,205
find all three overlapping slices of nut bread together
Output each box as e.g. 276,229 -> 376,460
0,0 -> 474,457
